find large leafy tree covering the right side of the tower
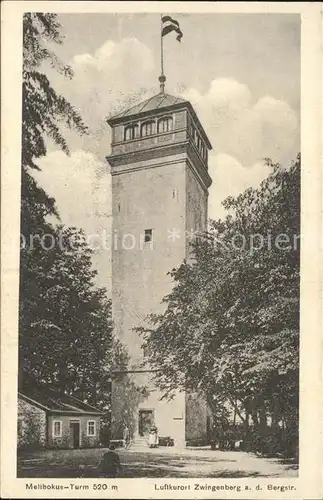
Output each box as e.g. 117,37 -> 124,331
139,156 -> 300,456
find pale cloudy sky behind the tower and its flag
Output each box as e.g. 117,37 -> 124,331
36,13 -> 300,285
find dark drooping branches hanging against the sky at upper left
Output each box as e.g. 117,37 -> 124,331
21,13 -> 87,241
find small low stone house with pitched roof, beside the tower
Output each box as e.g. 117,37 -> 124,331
18,384 -> 103,449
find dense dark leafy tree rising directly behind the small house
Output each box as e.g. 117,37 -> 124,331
19,227 -> 112,404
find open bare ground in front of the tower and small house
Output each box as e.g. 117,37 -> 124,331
18,448 -> 298,478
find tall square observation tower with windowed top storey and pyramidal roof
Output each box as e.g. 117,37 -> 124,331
107,80 -> 212,446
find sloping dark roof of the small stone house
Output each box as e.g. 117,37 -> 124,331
18,383 -> 103,416
